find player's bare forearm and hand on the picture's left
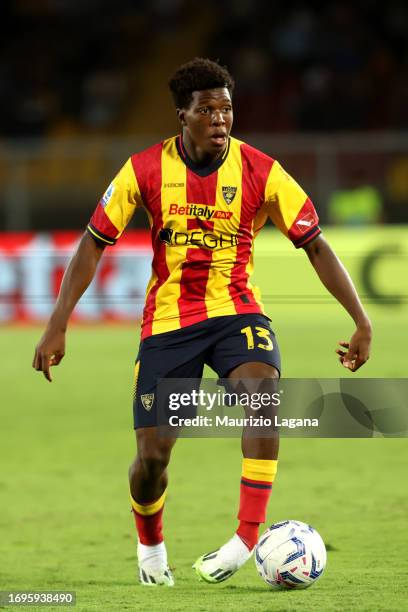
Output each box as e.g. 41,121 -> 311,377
33,233 -> 104,382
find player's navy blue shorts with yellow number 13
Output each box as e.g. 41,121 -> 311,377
133,314 -> 281,429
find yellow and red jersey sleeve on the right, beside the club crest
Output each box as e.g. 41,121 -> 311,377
264,161 -> 321,248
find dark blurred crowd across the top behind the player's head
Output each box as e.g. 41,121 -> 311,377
0,0 -> 408,137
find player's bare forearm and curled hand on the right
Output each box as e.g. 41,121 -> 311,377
303,234 -> 372,372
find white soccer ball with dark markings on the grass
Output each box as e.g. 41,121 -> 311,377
255,521 -> 327,589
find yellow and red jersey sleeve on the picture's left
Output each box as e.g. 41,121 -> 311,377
87,158 -> 143,246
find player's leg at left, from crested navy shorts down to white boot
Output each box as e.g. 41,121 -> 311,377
129,326 -> 205,586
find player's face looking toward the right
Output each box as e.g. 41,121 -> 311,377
178,87 -> 233,160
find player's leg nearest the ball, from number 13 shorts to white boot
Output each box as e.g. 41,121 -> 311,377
195,315 -> 280,583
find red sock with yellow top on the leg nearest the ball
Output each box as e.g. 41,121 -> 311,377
237,458 -> 278,550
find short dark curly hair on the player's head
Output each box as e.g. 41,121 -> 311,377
169,57 -> 234,108
